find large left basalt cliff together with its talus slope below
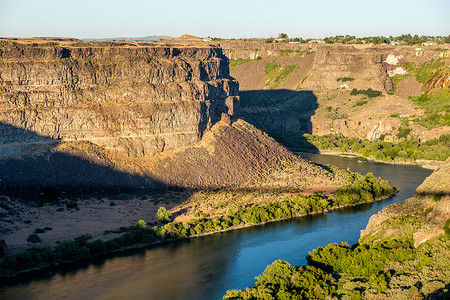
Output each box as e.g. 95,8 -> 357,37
0,39 -> 341,196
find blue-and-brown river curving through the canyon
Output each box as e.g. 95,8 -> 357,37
0,154 -> 432,300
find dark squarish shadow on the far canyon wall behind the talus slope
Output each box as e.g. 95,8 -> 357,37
239,89 -> 319,153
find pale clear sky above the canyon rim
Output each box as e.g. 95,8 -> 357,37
0,0 -> 450,38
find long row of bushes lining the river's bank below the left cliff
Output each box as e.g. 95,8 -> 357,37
0,170 -> 397,276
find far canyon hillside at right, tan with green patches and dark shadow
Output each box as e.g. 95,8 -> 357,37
212,41 -> 450,144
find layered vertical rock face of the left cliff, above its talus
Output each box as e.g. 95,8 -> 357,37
0,39 -> 239,156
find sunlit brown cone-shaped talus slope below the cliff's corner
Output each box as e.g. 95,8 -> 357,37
149,119 -> 341,188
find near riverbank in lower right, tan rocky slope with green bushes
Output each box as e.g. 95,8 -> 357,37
223,159 -> 450,300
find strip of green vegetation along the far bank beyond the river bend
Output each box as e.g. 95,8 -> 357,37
305,134 -> 450,162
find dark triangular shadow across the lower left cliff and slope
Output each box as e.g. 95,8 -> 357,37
0,123 -> 184,201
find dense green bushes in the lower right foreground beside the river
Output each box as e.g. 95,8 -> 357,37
223,235 -> 450,299
